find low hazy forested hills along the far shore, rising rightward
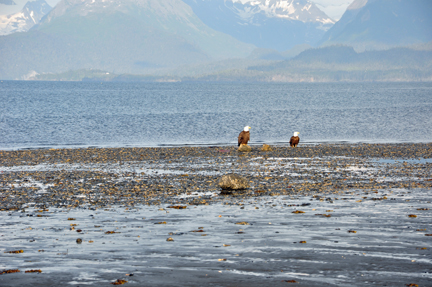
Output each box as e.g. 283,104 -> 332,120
34,46 -> 432,82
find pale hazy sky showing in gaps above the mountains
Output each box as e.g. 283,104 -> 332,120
0,0 -> 354,20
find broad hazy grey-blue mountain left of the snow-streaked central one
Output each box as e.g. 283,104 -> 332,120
0,0 -> 254,79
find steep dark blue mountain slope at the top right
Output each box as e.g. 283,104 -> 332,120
318,0 -> 432,51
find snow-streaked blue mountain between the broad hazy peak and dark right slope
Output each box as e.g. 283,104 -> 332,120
183,0 -> 335,51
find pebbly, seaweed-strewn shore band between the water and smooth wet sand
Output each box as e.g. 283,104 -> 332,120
0,143 -> 432,210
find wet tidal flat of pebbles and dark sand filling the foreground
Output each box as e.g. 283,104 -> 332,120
0,143 -> 432,286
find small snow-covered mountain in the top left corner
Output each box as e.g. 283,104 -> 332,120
0,0 -> 51,35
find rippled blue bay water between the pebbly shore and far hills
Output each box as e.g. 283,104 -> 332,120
0,81 -> 432,149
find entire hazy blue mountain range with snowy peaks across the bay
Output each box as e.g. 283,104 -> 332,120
0,0 -> 432,80
